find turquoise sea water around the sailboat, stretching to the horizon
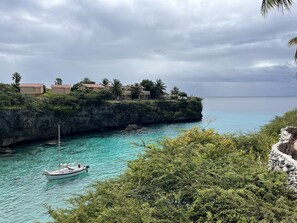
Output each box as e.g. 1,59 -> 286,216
0,97 -> 297,223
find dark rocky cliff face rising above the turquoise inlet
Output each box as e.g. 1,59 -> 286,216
0,101 -> 202,147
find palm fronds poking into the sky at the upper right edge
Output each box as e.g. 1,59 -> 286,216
261,0 -> 297,63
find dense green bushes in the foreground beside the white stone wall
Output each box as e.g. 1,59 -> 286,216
49,111 -> 297,223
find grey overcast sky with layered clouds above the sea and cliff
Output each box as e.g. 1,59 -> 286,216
0,0 -> 297,97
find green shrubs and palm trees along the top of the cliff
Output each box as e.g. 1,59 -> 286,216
0,72 -> 194,113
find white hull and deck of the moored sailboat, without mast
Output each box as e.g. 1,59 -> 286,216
43,164 -> 90,180
